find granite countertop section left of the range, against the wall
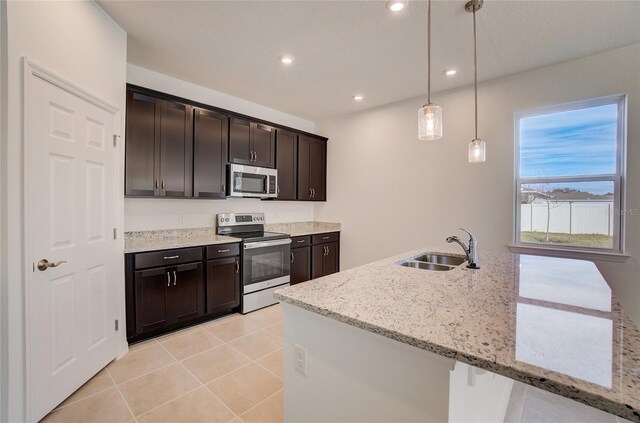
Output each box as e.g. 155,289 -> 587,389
124,228 -> 242,254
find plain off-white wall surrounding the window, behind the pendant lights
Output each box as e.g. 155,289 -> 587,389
315,44 -> 640,322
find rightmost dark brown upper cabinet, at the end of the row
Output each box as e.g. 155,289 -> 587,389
298,135 -> 327,201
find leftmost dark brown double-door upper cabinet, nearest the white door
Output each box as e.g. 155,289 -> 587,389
125,90 -> 193,198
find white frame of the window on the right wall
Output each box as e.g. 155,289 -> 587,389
510,94 -> 627,259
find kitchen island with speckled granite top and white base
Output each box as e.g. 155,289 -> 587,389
276,248 -> 640,422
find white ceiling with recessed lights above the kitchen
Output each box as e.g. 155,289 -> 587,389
98,0 -> 640,120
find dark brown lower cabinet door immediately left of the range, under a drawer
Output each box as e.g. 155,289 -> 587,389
207,257 -> 240,314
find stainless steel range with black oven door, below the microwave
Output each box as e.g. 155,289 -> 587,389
216,213 -> 291,314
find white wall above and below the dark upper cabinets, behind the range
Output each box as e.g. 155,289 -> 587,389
124,64 -> 315,231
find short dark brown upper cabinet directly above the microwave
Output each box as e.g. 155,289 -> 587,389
229,117 -> 276,167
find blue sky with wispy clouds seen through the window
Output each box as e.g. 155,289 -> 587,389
520,104 -> 618,194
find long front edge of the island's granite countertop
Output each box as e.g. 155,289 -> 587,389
273,291 -> 640,422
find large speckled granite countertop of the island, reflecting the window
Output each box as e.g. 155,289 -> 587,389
275,248 -> 640,422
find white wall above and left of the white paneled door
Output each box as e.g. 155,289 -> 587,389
0,1 -> 126,422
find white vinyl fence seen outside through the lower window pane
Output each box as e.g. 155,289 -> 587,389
520,200 -> 615,235
